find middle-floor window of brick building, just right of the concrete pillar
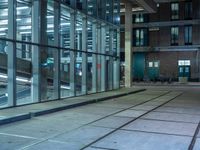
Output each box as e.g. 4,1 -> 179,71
133,29 -> 148,46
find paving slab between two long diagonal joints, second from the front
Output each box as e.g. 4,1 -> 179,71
90,116 -> 132,128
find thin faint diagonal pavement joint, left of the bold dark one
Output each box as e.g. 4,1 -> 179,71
19,91 -> 172,150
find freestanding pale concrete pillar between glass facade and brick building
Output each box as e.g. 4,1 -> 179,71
125,3 -> 132,87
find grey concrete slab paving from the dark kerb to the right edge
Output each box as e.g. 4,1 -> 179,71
0,87 -> 200,150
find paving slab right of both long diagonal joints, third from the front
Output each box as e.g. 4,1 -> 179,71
142,112 -> 200,123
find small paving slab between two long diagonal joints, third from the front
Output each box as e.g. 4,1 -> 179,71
114,109 -> 147,118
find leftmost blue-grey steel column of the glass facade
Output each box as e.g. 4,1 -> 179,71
7,0 -> 17,106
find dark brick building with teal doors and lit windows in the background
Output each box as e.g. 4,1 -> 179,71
121,0 -> 200,81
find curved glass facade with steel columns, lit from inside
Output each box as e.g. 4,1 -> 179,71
0,0 -> 120,107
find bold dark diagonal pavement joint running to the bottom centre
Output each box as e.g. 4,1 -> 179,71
80,93 -> 183,150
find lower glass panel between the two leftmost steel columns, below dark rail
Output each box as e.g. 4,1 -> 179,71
16,43 -> 31,105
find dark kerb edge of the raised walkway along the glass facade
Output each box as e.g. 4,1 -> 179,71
0,89 -> 146,126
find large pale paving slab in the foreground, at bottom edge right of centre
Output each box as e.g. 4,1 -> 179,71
92,131 -> 192,150
